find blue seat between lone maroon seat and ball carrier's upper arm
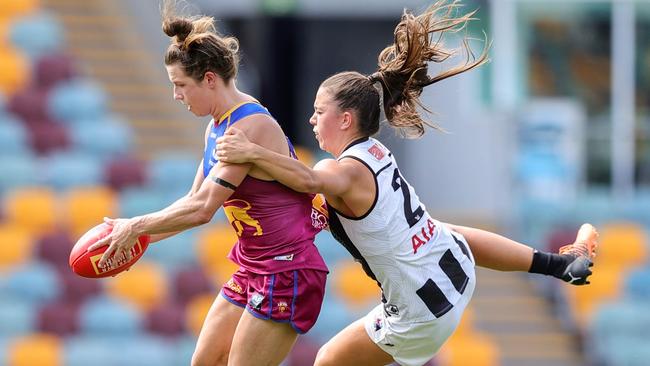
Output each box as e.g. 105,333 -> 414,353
149,153 -> 200,193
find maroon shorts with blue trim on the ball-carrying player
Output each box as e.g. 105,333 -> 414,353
221,268 -> 327,334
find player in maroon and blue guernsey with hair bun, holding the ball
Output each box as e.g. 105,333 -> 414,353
90,1 -> 327,365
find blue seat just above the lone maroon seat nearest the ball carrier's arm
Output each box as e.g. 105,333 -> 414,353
71,117 -> 133,160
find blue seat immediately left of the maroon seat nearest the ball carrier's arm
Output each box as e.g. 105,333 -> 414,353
44,152 -> 104,190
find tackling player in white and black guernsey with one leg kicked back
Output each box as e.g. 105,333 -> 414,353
217,1 -> 597,366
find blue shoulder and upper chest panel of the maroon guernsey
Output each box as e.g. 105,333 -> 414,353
203,101 -> 296,178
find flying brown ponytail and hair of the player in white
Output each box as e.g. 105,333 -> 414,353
321,0 -> 489,138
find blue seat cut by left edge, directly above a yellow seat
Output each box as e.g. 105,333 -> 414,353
0,154 -> 43,191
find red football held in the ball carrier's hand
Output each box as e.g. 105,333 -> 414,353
69,223 -> 150,278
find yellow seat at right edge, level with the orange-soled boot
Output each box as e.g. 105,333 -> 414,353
594,222 -> 648,267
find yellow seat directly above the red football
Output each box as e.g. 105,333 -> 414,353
62,187 -> 118,237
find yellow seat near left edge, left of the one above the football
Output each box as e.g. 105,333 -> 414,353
5,187 -> 59,234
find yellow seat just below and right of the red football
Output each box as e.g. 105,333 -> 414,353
107,260 -> 169,312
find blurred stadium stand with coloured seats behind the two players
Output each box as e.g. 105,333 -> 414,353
0,0 -> 650,366
